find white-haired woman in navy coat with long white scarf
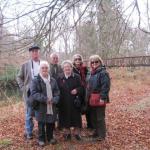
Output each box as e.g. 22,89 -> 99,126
30,61 -> 60,146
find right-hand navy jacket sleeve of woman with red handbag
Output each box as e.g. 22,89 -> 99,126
100,72 -> 110,101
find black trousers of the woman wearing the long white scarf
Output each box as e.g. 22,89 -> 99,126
38,122 -> 55,142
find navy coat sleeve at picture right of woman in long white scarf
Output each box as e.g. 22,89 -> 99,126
52,80 -> 60,104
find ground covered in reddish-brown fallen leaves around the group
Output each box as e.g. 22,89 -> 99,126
0,68 -> 150,150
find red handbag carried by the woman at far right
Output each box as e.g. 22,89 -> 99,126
89,93 -> 106,107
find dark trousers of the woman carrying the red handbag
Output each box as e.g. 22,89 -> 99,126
91,106 -> 106,138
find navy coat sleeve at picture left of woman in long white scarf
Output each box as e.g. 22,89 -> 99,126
30,79 -> 47,103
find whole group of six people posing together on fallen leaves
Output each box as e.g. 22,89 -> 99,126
17,46 -> 110,146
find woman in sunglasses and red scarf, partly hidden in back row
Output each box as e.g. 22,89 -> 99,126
73,54 -> 92,129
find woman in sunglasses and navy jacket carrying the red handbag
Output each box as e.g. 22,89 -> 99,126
87,55 -> 110,140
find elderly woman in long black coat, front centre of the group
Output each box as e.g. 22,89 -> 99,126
58,60 -> 82,140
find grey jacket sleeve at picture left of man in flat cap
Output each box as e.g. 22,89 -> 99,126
16,64 -> 25,91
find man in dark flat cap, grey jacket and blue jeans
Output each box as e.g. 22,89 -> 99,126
17,46 -> 40,139
